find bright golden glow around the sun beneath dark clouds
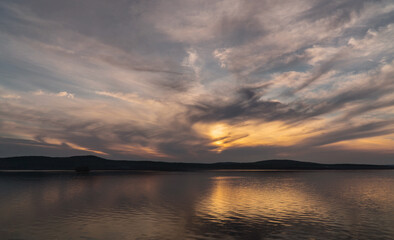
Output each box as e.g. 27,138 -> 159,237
194,120 -> 325,152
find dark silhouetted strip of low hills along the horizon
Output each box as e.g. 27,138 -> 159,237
0,155 -> 394,172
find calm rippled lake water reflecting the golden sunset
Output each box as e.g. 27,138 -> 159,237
0,170 -> 394,239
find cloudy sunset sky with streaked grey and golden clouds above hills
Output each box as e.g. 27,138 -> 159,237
0,0 -> 394,164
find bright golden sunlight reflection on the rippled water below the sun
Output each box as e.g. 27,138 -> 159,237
197,178 -> 329,221
